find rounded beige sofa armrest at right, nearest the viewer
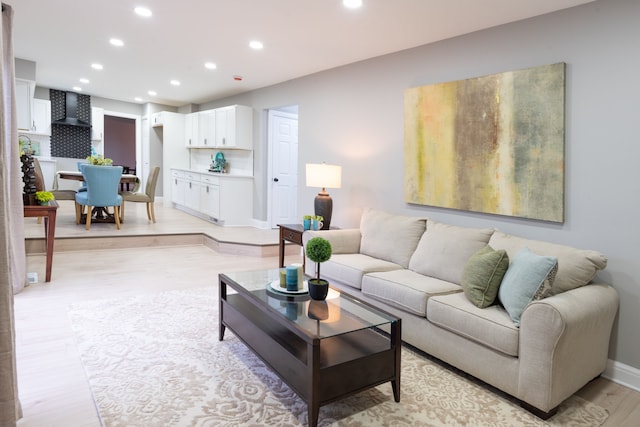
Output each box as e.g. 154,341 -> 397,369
518,283 -> 619,411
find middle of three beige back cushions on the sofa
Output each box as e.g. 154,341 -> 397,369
409,220 -> 493,285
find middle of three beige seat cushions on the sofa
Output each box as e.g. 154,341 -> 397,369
362,269 -> 462,317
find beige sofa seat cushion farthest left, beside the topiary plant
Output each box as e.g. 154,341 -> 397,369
318,254 -> 402,289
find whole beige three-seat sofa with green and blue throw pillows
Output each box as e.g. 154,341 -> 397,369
303,209 -> 618,418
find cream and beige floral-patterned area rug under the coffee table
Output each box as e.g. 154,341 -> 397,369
69,287 -> 608,427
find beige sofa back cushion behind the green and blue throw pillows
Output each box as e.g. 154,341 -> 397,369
489,231 -> 607,295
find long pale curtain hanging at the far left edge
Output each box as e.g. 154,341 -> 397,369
0,4 -> 26,426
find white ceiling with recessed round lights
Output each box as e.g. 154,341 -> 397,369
11,0 -> 593,106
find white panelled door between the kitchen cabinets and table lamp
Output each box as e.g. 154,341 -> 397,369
267,105 -> 300,228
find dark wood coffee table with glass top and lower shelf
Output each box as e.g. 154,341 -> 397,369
219,269 -> 402,427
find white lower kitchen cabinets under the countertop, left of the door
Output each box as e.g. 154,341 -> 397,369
171,169 -> 253,226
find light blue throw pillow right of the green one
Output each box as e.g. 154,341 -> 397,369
498,248 -> 558,326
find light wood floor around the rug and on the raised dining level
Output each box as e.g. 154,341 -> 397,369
15,201 -> 640,427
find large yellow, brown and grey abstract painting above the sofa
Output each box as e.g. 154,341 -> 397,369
404,63 -> 565,223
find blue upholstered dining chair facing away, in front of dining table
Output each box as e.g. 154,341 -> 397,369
76,165 -> 122,230
